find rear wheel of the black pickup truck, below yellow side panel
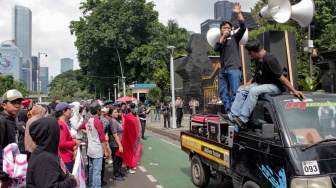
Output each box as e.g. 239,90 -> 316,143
190,155 -> 210,187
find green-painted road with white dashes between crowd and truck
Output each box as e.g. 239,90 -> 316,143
82,131 -> 232,188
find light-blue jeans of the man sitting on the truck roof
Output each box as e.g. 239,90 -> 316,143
228,82 -> 282,123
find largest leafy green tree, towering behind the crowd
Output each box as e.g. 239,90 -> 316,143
70,0 -> 158,92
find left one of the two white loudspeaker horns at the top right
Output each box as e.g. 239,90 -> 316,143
259,0 -> 292,23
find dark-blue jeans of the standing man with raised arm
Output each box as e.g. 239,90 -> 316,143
219,68 -> 242,113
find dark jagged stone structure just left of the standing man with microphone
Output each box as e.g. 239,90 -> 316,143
175,34 -> 213,112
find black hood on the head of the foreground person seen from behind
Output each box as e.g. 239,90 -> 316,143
29,117 -> 60,154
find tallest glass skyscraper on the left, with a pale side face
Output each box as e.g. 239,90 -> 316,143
12,5 -> 32,89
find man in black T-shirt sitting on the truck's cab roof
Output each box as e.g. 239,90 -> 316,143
218,39 -> 306,128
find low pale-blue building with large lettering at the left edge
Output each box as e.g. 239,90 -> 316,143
0,41 -> 22,81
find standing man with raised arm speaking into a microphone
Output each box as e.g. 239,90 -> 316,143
214,3 -> 246,112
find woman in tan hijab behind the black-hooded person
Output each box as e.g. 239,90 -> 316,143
24,105 -> 46,153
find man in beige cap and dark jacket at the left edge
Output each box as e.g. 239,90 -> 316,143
0,89 -> 23,187
